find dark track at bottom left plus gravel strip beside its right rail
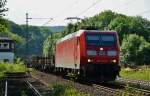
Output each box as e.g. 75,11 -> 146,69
5,73 -> 50,96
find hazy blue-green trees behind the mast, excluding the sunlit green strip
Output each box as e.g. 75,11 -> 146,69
10,23 -> 51,57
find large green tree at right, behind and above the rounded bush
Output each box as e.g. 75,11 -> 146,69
109,16 -> 149,41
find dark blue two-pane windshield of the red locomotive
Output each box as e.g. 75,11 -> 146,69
86,34 -> 115,46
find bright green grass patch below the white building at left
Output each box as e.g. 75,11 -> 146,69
0,62 -> 26,77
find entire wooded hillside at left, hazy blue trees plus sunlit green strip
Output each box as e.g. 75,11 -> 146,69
0,19 -> 51,57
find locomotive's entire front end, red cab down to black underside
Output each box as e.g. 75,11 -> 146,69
81,30 -> 120,81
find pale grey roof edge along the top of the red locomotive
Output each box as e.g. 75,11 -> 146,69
56,30 -> 116,44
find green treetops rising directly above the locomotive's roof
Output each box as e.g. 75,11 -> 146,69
62,10 -> 117,36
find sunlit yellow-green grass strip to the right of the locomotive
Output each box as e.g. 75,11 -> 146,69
120,66 -> 150,81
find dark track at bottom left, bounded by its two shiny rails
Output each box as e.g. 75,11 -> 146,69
4,72 -> 42,96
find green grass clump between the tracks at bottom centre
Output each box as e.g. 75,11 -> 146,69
52,84 -> 90,96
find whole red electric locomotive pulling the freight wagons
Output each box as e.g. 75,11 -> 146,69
55,30 -> 120,81
